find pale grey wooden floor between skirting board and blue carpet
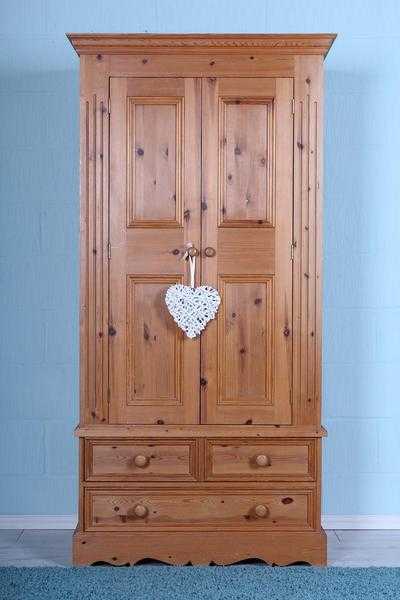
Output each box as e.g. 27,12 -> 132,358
0,529 -> 400,567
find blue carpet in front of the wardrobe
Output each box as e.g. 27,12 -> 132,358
0,565 -> 400,600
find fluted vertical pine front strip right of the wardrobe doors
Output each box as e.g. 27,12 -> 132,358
293,57 -> 323,425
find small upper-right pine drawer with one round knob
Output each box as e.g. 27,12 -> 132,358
206,438 -> 316,481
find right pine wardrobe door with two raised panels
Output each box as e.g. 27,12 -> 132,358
201,78 -> 293,424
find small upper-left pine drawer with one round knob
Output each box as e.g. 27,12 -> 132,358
85,439 -> 199,481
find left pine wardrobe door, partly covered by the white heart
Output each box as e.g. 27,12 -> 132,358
109,77 -> 201,424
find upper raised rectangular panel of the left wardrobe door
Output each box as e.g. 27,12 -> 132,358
127,97 -> 183,227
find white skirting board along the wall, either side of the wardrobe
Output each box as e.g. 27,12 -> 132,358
0,515 -> 400,529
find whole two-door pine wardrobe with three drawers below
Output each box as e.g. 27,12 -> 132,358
68,34 -> 335,565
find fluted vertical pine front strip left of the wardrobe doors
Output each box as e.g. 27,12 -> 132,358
79,56 -> 108,425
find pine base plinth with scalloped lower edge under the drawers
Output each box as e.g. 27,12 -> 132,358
73,530 -> 326,566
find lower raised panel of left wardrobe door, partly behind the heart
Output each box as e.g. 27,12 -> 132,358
126,275 -> 183,406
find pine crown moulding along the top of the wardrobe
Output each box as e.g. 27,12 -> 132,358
67,33 -> 336,56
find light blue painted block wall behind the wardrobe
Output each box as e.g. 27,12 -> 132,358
0,0 -> 400,515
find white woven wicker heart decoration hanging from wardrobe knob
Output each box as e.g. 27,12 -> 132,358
165,284 -> 221,338
